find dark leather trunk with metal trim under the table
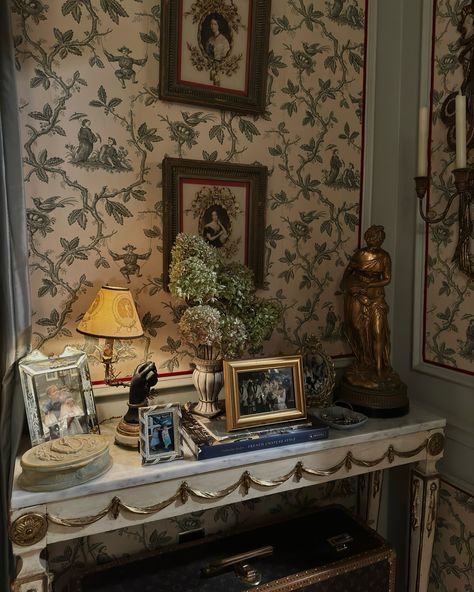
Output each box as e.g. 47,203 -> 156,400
72,505 -> 395,592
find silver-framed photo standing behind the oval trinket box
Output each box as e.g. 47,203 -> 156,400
19,347 -> 100,446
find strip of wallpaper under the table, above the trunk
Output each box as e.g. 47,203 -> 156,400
48,478 -> 357,592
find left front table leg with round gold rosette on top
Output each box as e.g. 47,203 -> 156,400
10,512 -> 52,592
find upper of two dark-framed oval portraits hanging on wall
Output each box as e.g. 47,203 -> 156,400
160,0 -> 271,113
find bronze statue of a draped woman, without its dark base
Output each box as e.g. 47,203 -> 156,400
341,225 -> 400,389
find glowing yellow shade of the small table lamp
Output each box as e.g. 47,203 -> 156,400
77,286 -> 143,339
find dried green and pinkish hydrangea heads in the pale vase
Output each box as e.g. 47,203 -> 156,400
169,233 -> 280,360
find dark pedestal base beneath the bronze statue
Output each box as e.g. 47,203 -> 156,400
335,376 -> 410,417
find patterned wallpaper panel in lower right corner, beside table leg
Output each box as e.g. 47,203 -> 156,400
428,481 -> 474,592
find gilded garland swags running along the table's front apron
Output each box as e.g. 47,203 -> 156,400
39,439 -> 438,527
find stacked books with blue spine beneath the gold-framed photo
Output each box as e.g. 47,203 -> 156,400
181,407 -> 329,460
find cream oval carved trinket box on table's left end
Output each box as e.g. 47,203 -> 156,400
18,434 -> 112,491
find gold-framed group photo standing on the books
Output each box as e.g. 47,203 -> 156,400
224,356 -> 306,431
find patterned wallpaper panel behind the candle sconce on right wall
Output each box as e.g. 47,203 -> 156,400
424,0 -> 474,373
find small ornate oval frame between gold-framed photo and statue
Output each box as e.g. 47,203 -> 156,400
302,336 -> 336,407
